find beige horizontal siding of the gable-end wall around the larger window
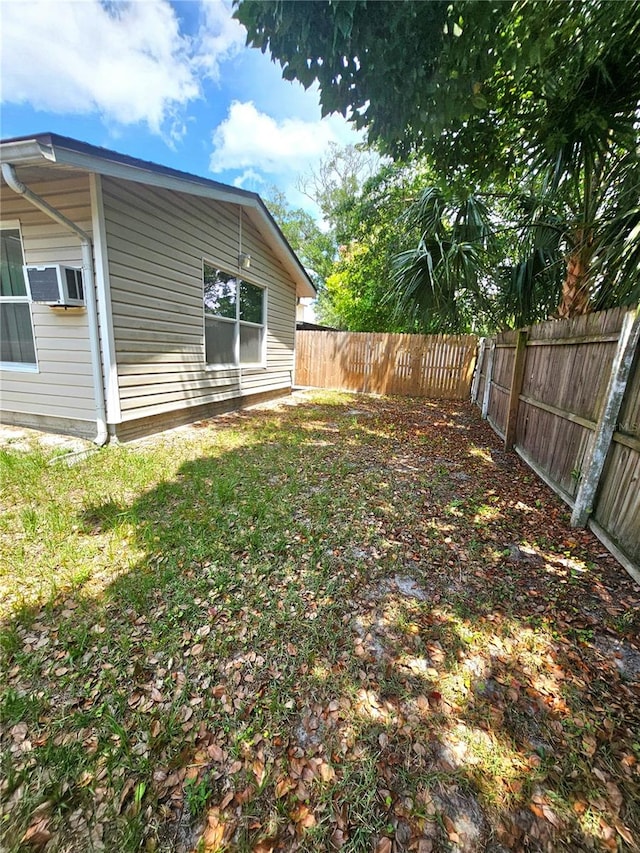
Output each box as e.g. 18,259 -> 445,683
102,177 -> 296,421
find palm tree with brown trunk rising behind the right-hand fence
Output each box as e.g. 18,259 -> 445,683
512,2 -> 640,317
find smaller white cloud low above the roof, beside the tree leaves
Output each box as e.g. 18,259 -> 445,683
209,101 -> 355,174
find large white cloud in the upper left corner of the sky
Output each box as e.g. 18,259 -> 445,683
1,0 -> 243,136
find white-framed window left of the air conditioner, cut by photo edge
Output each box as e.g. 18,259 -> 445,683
0,228 -> 36,368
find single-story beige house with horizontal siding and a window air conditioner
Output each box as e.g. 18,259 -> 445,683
0,134 -> 315,444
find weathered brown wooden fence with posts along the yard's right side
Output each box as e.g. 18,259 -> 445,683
471,308 -> 640,581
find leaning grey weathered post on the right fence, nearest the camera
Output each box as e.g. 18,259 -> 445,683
571,308 -> 640,527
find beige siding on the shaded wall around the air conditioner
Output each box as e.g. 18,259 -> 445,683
0,170 -> 95,421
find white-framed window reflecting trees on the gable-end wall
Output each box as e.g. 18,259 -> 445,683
204,261 -> 265,367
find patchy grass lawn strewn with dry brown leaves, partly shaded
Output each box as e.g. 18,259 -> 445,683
0,393 -> 640,853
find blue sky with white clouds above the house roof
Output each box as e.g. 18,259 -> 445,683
0,0 -> 360,209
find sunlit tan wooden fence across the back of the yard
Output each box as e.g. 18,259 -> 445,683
295,331 -> 478,400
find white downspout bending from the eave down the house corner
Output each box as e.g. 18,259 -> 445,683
2,163 -> 109,447
